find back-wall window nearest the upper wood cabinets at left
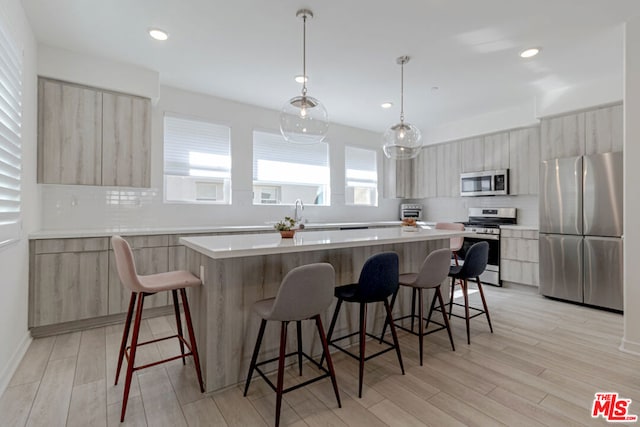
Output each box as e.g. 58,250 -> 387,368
164,115 -> 231,204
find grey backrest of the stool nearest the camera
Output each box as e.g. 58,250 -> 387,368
269,263 -> 336,321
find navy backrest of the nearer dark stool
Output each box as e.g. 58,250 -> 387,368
356,252 -> 400,302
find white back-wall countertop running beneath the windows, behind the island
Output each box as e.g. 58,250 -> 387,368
29,221 -> 400,239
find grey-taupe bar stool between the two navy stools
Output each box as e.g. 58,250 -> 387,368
383,249 -> 456,366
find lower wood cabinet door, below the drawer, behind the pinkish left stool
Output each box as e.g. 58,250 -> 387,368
109,246 -> 169,314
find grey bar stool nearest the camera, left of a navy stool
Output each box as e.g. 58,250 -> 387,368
244,263 -> 342,427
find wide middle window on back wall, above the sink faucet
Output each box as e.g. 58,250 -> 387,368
253,131 -> 330,206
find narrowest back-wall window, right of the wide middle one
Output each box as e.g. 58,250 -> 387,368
344,146 -> 378,206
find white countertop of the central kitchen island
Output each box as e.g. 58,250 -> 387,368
180,227 -> 468,259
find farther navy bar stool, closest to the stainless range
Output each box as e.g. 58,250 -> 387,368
449,242 -> 493,344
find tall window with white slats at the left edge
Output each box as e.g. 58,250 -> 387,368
0,17 -> 22,246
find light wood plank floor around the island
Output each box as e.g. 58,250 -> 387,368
0,286 -> 640,427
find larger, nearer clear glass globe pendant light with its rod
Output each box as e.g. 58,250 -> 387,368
280,9 -> 329,144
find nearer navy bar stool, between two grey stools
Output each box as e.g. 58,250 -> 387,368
320,252 -> 404,397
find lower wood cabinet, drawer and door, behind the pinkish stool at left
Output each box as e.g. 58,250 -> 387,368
109,235 -> 169,314
